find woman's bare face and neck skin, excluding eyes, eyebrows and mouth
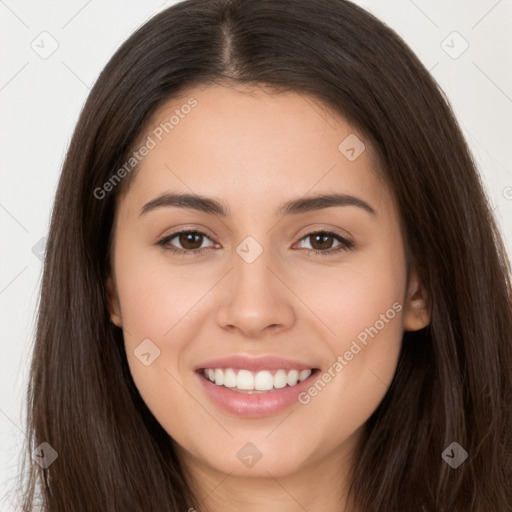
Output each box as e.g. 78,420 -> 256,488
107,85 -> 430,512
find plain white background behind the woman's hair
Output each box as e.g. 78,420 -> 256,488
0,0 -> 512,512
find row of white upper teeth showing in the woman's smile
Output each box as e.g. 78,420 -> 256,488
203,368 -> 312,391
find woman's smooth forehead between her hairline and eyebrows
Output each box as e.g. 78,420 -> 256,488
120,85 -> 390,218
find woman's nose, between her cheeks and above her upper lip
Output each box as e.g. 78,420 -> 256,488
217,245 -> 295,338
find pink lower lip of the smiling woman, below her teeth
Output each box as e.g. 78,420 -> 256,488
196,370 -> 318,418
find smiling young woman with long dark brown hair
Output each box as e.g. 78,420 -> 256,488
18,0 -> 512,512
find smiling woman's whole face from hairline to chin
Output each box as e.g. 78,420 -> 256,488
107,85 -> 428,484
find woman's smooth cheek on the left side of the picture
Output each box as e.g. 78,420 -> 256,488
115,241 -> 200,414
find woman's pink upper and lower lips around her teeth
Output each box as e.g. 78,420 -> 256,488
195,355 -> 320,418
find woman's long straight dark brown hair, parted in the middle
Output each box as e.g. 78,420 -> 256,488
18,0 -> 512,512
